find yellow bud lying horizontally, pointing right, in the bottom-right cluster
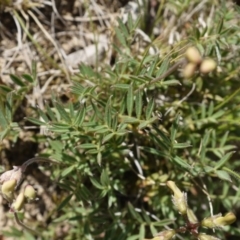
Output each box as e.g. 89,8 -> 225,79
201,212 -> 236,228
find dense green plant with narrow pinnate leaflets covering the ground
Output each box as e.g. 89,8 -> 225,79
0,1 -> 240,240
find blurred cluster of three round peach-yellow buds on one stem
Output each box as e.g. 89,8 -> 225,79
183,47 -> 217,78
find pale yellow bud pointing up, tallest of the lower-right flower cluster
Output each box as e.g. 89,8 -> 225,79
167,181 -> 187,215
